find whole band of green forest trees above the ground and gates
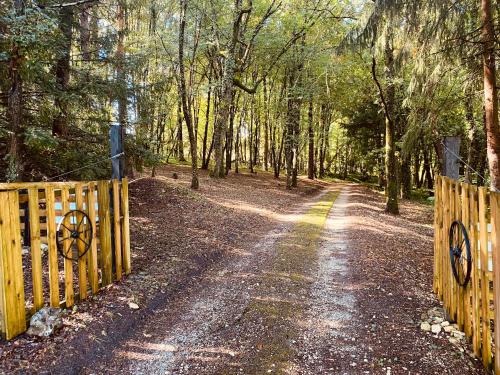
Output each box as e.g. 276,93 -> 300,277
0,0 -> 500,213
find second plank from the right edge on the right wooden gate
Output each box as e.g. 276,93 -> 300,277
479,187 -> 491,367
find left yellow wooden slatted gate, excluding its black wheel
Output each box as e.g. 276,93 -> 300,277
0,179 -> 130,339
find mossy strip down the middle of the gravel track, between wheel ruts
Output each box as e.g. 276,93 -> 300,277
245,191 -> 338,374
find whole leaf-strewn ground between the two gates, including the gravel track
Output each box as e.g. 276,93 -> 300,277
0,170 -> 484,375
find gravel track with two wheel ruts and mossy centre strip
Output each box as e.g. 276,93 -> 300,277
84,187 -> 354,374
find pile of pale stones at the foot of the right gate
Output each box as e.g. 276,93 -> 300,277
420,307 -> 465,347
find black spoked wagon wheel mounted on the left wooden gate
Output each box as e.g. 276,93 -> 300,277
56,210 -> 94,260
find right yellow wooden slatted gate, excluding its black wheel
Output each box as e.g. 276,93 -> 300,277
434,176 -> 500,374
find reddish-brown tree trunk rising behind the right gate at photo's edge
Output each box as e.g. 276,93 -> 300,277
481,0 -> 500,191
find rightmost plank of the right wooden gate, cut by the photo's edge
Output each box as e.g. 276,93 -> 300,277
490,192 -> 500,374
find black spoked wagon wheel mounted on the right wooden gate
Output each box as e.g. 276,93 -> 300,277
450,221 -> 472,287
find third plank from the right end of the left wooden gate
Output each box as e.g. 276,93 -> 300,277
97,181 -> 113,285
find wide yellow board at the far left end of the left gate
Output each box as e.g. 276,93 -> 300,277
0,191 -> 26,340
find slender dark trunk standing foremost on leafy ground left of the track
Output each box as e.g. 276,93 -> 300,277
179,0 -> 199,189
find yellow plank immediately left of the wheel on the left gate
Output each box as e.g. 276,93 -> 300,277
45,186 -> 60,307
